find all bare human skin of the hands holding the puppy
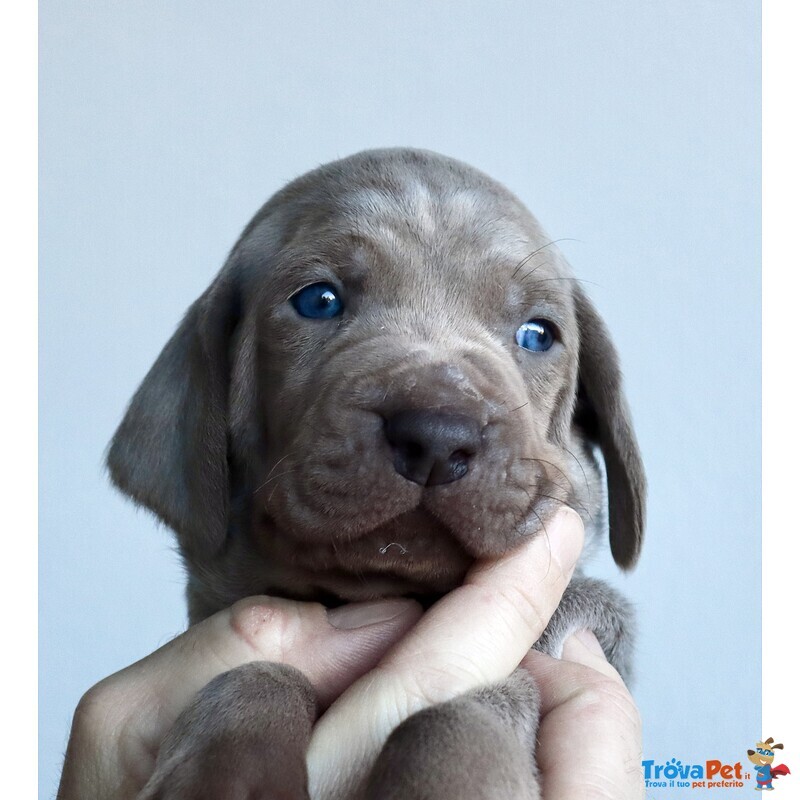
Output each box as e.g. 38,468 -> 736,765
58,511 -> 643,800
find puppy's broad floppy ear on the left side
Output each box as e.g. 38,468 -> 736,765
107,270 -> 240,555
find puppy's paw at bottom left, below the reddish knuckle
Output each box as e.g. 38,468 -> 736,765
137,662 -> 316,800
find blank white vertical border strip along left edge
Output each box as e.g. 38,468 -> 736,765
0,3 -> 38,797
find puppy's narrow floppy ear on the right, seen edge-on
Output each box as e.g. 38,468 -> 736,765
575,285 -> 646,569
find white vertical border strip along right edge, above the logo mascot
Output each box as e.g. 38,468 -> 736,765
764,0 -> 800,764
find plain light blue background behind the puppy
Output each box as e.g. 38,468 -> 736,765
40,0 -> 761,798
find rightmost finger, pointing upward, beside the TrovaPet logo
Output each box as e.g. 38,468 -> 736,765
522,631 -> 644,800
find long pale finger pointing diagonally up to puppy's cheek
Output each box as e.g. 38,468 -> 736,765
309,511 -> 583,796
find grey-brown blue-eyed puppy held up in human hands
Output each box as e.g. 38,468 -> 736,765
108,149 -> 645,800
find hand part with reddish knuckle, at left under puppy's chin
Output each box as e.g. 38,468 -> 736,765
58,597 -> 422,800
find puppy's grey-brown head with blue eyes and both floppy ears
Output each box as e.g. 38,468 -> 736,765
108,150 -> 644,599
